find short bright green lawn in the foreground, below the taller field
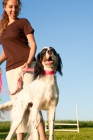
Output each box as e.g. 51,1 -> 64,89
0,127 -> 93,140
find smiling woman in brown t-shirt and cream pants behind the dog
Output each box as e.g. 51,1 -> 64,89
0,0 -> 46,140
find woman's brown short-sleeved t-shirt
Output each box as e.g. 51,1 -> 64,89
0,18 -> 34,71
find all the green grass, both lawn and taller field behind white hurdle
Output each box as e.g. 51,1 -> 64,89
0,120 -> 93,140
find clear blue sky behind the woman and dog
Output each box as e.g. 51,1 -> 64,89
0,0 -> 93,121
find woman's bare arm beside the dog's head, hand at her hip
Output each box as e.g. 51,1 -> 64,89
22,34 -> 37,69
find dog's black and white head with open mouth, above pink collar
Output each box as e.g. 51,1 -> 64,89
34,47 -> 62,78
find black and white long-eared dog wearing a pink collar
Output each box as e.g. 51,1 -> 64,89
0,47 -> 63,140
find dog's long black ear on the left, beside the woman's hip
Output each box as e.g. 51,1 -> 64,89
34,53 -> 43,79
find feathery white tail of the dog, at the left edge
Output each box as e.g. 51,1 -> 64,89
0,100 -> 13,119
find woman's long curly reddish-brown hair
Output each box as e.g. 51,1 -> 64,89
0,0 -> 21,35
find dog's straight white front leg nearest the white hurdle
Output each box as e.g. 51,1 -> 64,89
48,107 -> 55,140
